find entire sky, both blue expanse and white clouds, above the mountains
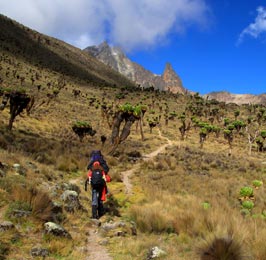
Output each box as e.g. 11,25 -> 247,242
0,0 -> 266,94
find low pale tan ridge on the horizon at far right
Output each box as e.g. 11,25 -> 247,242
205,91 -> 266,105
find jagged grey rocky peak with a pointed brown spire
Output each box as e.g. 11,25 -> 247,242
84,42 -> 186,93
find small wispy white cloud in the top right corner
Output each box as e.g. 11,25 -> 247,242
237,6 -> 266,44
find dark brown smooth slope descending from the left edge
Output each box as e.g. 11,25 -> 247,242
0,15 -> 135,87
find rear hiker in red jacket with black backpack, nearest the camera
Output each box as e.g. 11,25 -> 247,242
85,161 -> 111,219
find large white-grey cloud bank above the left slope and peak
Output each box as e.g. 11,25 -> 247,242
0,0 -> 209,50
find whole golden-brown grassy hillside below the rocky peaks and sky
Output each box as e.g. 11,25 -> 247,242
0,13 -> 266,260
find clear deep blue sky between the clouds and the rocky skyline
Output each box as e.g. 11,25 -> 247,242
127,0 -> 266,94
